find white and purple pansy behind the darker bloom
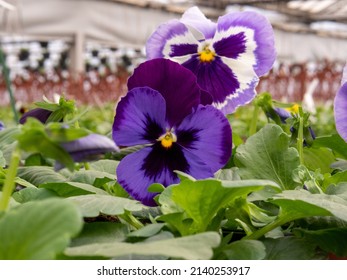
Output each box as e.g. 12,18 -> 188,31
146,7 -> 276,114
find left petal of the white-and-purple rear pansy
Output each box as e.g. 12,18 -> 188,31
146,20 -> 199,59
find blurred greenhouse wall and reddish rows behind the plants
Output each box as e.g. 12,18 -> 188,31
0,0 -> 347,106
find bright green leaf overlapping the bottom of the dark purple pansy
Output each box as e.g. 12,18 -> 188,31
159,179 -> 279,233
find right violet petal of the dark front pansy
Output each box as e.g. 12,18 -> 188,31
177,105 -> 232,172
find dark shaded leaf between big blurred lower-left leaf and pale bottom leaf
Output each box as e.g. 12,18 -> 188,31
71,222 -> 128,247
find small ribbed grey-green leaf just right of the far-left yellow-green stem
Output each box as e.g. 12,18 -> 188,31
17,166 -> 66,186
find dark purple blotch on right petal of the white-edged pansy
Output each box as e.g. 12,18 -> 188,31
213,32 -> 246,59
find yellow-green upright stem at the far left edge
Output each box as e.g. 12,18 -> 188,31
0,148 -> 20,212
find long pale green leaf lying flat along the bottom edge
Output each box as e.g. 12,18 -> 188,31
65,232 -> 220,260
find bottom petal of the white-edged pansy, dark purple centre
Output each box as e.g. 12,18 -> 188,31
183,57 -> 258,114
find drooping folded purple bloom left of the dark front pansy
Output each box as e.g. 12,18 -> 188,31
60,134 -> 119,162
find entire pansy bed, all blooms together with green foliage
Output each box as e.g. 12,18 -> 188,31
0,7 -> 347,261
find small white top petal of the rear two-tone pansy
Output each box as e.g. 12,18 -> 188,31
180,7 -> 217,39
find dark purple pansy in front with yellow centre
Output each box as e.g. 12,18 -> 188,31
113,59 -> 231,206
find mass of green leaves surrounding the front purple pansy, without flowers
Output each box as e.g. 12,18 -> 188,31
0,99 -> 347,260
